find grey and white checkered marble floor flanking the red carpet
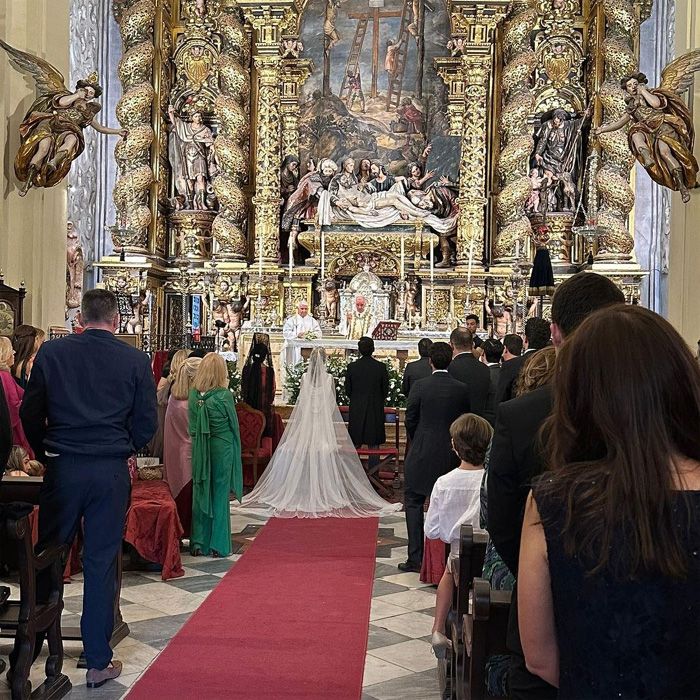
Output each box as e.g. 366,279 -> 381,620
0,514 -> 440,700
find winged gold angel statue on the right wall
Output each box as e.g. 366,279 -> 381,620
595,50 -> 700,202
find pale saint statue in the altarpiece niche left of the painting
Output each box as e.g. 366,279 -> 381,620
168,105 -> 219,210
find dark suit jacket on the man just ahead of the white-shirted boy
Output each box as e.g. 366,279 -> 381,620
404,372 -> 469,496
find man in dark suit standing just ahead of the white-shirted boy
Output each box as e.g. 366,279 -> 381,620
399,343 -> 470,571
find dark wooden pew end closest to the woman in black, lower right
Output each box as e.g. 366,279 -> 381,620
460,578 -> 511,700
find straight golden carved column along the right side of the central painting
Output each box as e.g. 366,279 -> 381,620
436,0 -> 509,272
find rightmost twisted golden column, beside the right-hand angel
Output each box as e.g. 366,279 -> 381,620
589,0 -> 639,263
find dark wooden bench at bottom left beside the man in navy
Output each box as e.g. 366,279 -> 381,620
0,507 -> 72,700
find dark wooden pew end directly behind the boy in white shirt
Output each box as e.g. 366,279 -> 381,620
446,525 -> 488,700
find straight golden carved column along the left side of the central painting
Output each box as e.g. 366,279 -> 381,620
239,0 -> 292,264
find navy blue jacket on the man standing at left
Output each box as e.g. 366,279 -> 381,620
20,329 -> 158,461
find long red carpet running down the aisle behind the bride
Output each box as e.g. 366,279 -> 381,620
128,518 -> 377,700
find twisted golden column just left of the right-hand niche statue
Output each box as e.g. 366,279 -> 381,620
493,0 -> 537,262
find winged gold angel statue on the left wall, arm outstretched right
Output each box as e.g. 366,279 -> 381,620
0,40 -> 127,197
